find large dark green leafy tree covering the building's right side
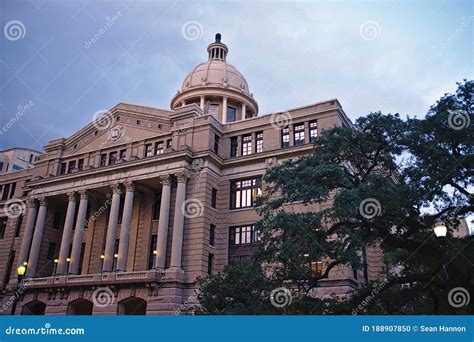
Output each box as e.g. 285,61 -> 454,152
197,80 -> 474,314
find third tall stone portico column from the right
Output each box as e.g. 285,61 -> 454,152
117,182 -> 135,272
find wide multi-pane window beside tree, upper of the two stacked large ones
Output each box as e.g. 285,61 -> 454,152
230,177 -> 262,209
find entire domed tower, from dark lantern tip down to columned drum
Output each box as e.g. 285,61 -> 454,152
171,33 -> 258,123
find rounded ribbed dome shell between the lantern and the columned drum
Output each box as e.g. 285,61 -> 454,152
181,59 -> 250,96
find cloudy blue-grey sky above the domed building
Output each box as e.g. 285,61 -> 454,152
0,0 -> 474,150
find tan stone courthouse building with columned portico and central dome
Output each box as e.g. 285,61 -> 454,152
0,34 -> 374,315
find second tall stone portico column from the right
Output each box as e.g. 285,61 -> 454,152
155,175 -> 171,268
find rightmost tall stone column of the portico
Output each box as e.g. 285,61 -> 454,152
170,171 -> 189,268
